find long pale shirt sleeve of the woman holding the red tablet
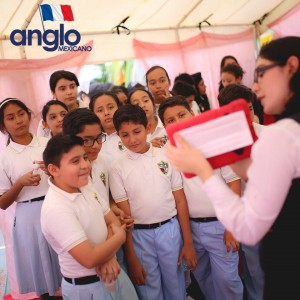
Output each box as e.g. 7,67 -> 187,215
203,119 -> 300,245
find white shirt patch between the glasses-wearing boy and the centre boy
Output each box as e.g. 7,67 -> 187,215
101,132 -> 126,166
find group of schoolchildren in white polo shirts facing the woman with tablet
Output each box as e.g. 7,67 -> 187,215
0,66 -> 261,300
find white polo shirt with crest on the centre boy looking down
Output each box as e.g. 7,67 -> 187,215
109,144 -> 182,224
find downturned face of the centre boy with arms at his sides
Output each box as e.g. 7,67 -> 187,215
118,122 -> 149,154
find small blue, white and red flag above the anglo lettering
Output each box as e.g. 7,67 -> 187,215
40,4 -> 74,21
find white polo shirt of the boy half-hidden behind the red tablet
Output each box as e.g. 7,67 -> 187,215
182,166 -> 240,218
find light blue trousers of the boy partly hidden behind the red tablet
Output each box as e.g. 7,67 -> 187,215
190,221 -> 243,300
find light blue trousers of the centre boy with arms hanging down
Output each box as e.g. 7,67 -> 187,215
132,218 -> 186,300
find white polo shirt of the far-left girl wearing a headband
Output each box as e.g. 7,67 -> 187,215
0,135 -> 49,202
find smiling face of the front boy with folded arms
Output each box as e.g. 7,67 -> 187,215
48,145 -> 91,193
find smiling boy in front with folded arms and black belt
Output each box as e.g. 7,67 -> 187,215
41,135 -> 137,300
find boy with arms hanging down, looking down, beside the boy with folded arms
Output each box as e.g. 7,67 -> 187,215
109,104 -> 196,300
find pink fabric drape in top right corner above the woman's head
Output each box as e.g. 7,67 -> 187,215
268,4 -> 300,38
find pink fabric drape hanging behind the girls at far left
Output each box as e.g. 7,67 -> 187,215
0,41 -> 93,300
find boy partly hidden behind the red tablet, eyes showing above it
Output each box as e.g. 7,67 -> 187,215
158,96 -> 243,300
